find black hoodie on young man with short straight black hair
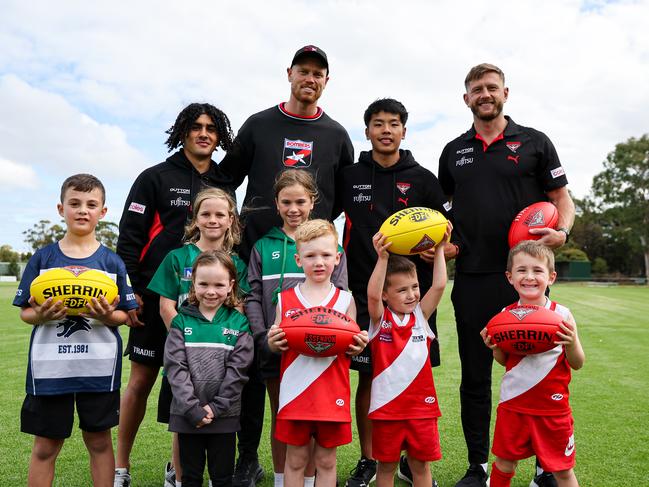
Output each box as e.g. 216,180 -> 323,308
339,150 -> 448,306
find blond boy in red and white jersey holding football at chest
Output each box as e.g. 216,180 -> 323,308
268,220 -> 368,487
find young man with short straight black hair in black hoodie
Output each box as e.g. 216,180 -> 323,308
337,98 -> 448,487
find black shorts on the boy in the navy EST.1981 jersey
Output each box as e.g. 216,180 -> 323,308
20,391 -> 119,440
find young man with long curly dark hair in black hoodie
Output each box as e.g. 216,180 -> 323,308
115,103 -> 233,487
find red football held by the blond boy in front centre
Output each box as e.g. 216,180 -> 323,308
279,306 -> 361,357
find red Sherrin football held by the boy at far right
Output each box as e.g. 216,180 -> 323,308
487,305 -> 563,355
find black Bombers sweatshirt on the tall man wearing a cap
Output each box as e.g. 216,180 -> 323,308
219,104 -> 354,263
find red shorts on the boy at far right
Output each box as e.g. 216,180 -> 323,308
491,408 -> 575,472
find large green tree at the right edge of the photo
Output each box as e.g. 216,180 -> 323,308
593,134 -> 649,280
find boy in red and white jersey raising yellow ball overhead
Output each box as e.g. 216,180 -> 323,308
367,223 -> 452,487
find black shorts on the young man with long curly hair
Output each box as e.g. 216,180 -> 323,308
124,294 -> 167,367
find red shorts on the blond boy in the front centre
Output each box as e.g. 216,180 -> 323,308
275,418 -> 352,448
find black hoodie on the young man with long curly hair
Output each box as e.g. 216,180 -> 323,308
117,149 -> 230,294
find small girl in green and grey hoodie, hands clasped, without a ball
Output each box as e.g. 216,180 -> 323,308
164,250 -> 253,487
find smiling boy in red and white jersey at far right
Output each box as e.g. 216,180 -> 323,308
481,240 -> 585,487
